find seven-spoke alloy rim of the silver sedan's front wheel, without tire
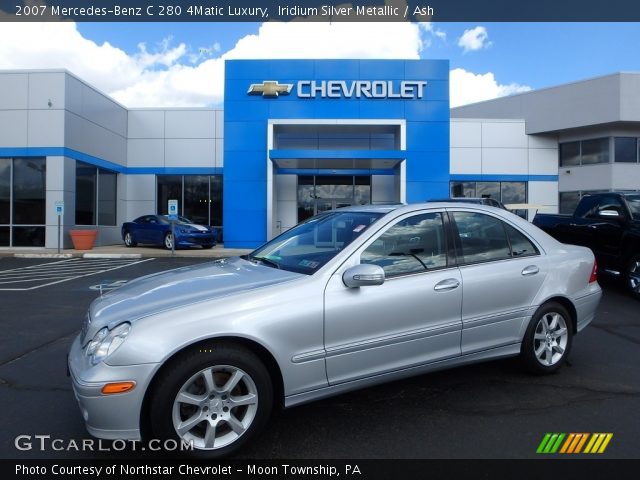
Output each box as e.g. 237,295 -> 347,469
172,365 -> 258,450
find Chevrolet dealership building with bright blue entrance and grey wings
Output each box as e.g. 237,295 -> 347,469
0,60 -> 640,248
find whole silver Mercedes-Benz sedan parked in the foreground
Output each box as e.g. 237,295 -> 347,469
69,203 -> 601,457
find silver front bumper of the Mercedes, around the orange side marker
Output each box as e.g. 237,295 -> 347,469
68,336 -> 157,440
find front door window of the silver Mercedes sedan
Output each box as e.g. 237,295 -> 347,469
360,212 -> 448,277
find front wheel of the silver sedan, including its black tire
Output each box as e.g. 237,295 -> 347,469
149,344 -> 273,459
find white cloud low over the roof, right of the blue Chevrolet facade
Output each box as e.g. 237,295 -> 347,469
449,68 -> 531,107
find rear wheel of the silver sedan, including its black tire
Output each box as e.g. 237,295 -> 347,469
520,302 -> 573,375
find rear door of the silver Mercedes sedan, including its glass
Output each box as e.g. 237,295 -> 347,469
449,211 -> 547,355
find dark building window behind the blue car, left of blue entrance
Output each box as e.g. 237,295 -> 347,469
156,175 -> 223,230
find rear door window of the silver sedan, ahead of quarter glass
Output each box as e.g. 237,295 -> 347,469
452,212 -> 511,263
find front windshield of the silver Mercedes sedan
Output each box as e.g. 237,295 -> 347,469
248,211 -> 384,275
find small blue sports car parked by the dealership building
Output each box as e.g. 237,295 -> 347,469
122,215 -> 216,250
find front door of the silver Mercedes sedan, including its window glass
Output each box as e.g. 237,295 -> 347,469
325,212 -> 462,384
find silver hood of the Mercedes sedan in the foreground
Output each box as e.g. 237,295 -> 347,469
83,257 -> 306,342
